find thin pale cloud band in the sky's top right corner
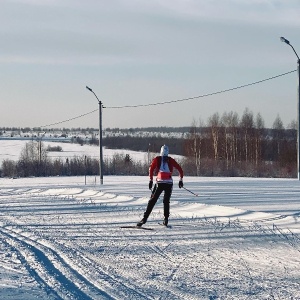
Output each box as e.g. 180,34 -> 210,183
136,0 -> 300,26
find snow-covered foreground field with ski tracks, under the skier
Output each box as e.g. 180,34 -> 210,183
0,176 -> 300,300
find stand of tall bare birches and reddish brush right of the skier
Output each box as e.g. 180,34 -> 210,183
185,109 -> 297,177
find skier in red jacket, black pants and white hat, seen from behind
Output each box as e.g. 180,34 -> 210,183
137,145 -> 183,227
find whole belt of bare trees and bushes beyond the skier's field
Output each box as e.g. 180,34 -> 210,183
0,109 -> 297,178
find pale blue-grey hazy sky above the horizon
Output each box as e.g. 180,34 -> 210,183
0,0 -> 300,128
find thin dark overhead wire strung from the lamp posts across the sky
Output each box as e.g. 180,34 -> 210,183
39,70 -> 297,128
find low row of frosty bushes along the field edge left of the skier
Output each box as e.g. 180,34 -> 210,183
0,141 -> 148,177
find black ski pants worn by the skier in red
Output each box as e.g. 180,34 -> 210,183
144,183 -> 173,221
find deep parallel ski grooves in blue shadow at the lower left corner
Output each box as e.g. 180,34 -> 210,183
1,228 -> 114,300
